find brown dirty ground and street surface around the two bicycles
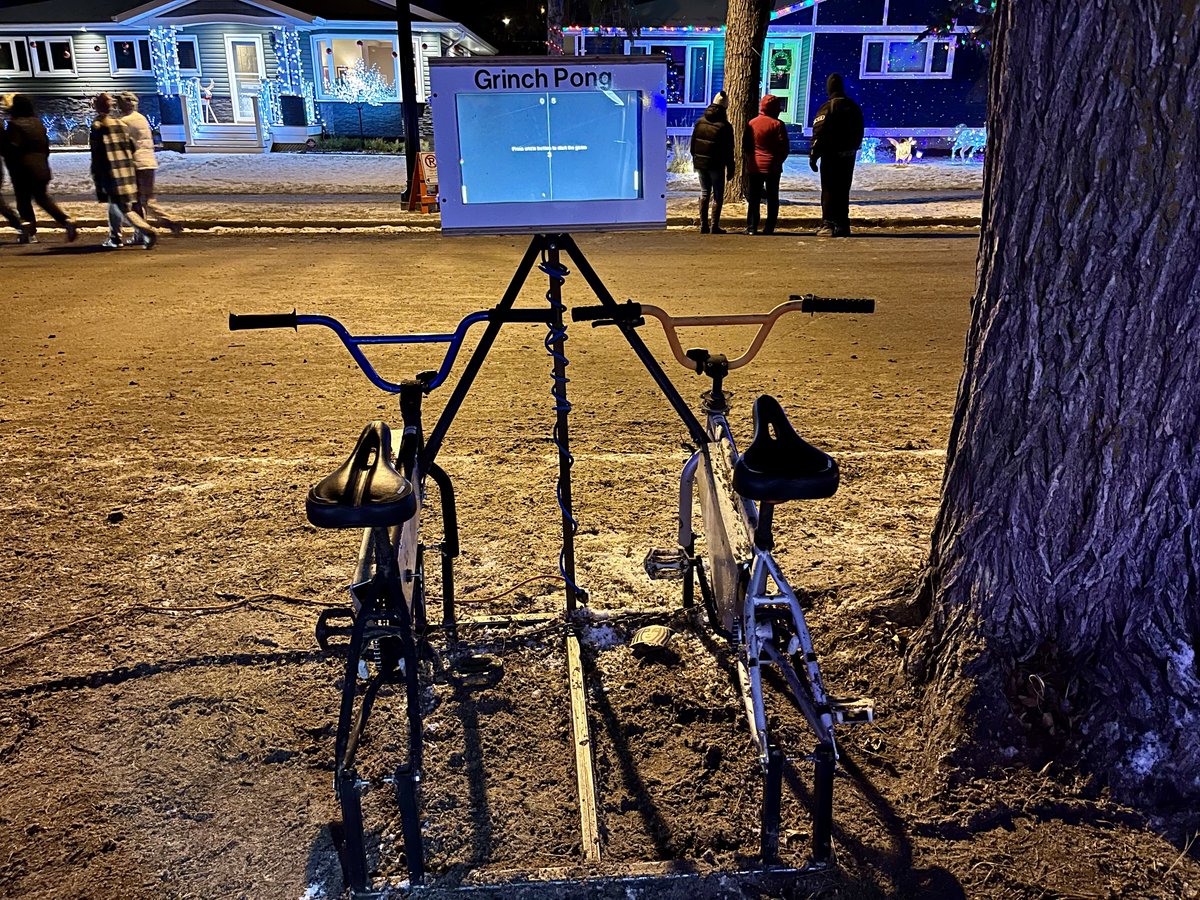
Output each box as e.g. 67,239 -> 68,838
0,232 -> 1200,900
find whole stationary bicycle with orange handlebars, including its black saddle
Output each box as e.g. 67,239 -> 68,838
571,294 -> 875,868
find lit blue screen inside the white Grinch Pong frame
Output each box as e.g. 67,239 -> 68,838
456,90 -> 642,204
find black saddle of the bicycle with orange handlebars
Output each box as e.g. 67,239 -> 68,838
733,394 -> 839,503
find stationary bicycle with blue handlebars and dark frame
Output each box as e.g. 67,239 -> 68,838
229,305 -> 566,895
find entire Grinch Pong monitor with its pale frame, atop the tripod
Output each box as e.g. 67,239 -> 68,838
430,56 -> 666,234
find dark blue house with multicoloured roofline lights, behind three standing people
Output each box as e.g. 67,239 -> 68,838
563,0 -> 988,146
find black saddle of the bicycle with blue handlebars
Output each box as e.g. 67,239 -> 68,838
305,421 -> 416,528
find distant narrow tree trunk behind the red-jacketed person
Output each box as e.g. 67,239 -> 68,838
725,0 -> 774,200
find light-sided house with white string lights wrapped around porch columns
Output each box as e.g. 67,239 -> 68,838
0,0 -> 496,152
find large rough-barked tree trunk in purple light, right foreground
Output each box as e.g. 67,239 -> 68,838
907,0 -> 1200,816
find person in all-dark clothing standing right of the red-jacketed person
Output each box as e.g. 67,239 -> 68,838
809,72 -> 863,238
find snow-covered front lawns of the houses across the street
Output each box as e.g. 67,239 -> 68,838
50,151 -> 983,194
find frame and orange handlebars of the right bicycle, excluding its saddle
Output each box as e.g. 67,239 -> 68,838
585,295 -> 875,866
